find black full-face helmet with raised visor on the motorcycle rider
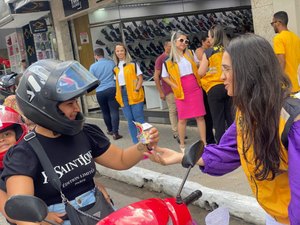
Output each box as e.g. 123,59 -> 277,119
16,59 -> 99,135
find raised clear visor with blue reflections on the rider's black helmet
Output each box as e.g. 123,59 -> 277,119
56,62 -> 97,95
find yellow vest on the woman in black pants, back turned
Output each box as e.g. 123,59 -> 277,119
201,46 -> 224,93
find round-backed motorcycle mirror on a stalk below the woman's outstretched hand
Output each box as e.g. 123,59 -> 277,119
181,140 -> 204,168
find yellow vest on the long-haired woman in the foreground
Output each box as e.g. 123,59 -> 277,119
236,109 -> 291,224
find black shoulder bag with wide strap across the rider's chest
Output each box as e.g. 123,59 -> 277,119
24,132 -> 114,225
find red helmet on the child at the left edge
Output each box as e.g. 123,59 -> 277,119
0,105 -> 28,143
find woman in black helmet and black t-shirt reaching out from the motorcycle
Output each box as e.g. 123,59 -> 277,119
2,60 -> 159,225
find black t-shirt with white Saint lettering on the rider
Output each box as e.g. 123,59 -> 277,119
2,124 -> 110,205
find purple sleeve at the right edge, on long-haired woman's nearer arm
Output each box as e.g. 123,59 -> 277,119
288,120 -> 300,225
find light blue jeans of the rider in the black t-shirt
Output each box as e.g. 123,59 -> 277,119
48,189 -> 96,225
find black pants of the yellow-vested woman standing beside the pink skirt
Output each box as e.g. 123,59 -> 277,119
207,84 -> 233,143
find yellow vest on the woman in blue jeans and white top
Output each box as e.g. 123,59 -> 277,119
114,63 -> 145,107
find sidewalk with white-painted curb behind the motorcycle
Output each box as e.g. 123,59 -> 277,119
86,114 -> 264,224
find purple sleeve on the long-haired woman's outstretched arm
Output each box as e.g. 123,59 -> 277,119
200,123 -> 241,176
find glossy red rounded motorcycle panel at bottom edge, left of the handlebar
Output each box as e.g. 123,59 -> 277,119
97,198 -> 170,225
